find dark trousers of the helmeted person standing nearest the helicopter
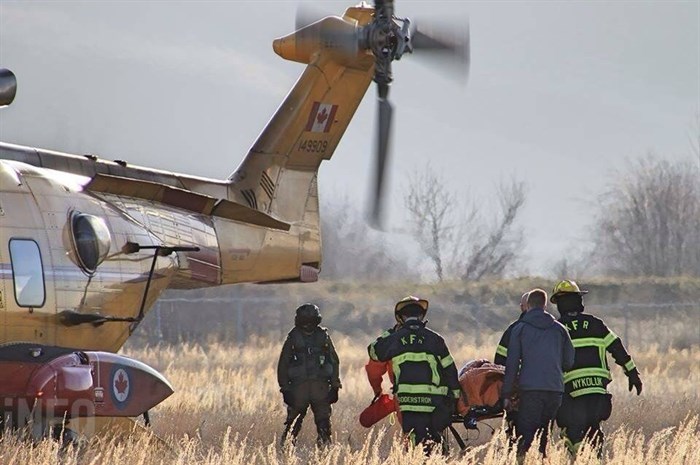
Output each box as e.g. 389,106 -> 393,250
282,379 -> 331,445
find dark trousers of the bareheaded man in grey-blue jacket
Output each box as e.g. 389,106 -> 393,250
515,391 -> 563,456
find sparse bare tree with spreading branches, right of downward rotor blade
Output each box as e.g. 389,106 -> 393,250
404,164 -> 525,281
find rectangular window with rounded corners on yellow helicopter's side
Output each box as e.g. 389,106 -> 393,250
10,239 -> 46,307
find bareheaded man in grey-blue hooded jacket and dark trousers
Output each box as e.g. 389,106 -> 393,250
501,289 -> 574,459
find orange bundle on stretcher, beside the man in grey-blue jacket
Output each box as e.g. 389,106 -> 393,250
457,359 -> 506,415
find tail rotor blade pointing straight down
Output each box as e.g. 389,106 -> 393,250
370,83 -> 394,229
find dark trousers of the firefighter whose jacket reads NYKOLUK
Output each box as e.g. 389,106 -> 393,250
557,394 -> 612,457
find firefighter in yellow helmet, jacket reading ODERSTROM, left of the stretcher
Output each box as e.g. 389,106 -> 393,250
367,296 -> 460,453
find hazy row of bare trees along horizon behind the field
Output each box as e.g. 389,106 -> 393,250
322,154 -> 700,281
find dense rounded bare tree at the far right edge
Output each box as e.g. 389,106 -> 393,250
595,155 -> 700,276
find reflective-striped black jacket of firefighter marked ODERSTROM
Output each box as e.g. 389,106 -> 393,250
367,320 -> 460,413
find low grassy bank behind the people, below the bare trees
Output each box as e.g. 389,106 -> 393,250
132,278 -> 700,348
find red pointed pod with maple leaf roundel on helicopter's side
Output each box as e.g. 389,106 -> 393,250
0,343 -> 173,418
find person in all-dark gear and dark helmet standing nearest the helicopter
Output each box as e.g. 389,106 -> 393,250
277,303 -> 341,446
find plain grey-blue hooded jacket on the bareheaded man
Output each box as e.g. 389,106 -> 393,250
501,308 -> 574,398
